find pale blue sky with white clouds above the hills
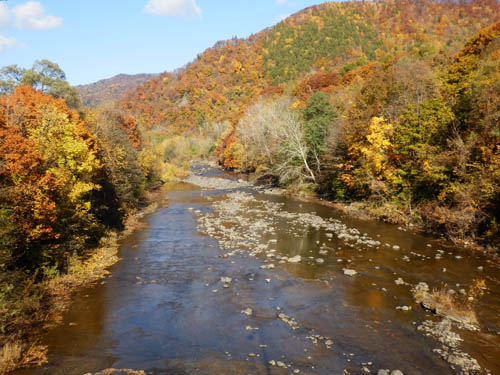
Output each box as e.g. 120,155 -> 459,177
0,0 -> 324,85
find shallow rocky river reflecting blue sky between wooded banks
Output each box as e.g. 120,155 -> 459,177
16,168 -> 500,375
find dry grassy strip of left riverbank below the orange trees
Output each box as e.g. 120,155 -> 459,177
0,189 -> 163,374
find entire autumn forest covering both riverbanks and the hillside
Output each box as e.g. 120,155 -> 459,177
0,0 -> 500,370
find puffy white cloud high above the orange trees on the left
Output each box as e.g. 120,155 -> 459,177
12,1 -> 63,30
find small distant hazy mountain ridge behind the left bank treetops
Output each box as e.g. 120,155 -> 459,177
76,74 -> 155,107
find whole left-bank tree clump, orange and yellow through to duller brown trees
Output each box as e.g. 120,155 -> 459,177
0,86 -> 162,271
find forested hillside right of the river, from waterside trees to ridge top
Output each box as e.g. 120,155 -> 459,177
119,0 -> 500,250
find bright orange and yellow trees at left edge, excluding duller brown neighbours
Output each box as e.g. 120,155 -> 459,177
0,87 -> 100,266
